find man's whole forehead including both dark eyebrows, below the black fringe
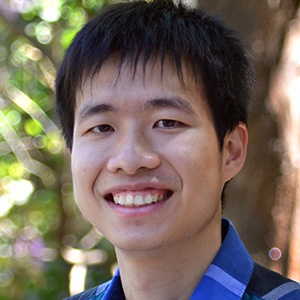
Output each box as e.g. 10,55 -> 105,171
75,57 -> 211,121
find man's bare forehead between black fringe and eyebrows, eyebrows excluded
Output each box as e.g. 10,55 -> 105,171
77,55 -> 203,101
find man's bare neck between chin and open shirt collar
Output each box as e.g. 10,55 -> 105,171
116,219 -> 221,300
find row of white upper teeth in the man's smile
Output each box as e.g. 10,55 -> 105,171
113,194 -> 163,206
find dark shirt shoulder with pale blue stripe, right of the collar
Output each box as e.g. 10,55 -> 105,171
243,264 -> 300,300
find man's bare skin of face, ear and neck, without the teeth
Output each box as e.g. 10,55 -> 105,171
71,60 -> 248,299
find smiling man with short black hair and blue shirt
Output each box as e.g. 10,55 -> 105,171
56,0 -> 300,300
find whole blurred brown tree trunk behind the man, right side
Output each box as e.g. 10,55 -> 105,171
198,0 -> 300,280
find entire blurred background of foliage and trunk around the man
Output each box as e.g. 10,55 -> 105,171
0,0 -> 300,300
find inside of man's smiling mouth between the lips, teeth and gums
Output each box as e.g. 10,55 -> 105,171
104,190 -> 173,207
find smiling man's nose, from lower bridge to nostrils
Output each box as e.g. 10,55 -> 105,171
107,128 -> 160,175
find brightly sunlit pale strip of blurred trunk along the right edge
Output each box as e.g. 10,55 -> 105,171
269,9 -> 300,281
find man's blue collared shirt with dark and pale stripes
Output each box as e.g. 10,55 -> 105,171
68,219 -> 300,300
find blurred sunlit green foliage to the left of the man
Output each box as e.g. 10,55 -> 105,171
0,0 -> 115,300
